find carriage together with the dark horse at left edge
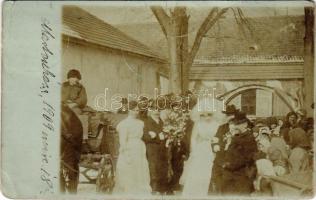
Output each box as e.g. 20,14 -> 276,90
61,105 -> 126,193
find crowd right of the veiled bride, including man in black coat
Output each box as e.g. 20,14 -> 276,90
212,106 -> 314,196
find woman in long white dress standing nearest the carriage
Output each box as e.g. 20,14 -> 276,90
114,101 -> 151,195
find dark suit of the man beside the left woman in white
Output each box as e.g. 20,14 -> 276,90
142,117 -> 169,192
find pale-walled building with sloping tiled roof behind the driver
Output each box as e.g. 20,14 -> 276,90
62,6 -> 168,108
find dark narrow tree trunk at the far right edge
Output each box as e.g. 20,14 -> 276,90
304,7 -> 314,117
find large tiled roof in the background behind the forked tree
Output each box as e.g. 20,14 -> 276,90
118,16 -> 305,63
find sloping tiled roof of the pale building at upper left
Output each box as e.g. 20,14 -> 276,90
63,6 -> 164,60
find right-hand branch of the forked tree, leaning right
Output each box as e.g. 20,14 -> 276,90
187,8 -> 229,64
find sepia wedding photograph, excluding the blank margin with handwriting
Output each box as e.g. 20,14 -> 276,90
59,2 -> 314,199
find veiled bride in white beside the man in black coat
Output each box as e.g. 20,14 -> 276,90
182,99 -> 219,197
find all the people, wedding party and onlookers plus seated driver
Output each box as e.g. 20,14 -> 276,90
62,71 -> 314,197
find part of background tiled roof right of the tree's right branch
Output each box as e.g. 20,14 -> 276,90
197,16 -> 305,60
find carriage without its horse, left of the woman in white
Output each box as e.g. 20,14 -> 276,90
79,112 -> 126,193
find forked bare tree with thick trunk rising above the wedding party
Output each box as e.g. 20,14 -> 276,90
151,6 -> 228,94
